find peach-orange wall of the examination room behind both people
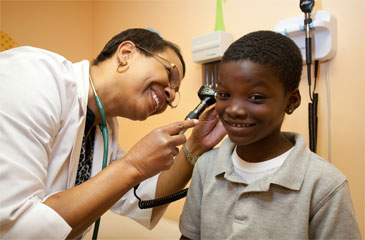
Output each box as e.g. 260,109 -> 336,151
0,0 -> 365,236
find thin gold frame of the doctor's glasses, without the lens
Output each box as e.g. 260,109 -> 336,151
136,45 -> 180,108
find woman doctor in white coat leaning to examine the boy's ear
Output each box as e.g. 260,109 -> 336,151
0,29 -> 225,239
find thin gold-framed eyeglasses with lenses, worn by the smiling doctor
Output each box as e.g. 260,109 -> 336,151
136,46 -> 180,108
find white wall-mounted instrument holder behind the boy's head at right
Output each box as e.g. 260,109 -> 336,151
274,10 -> 337,62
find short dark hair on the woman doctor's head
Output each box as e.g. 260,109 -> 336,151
92,28 -> 185,76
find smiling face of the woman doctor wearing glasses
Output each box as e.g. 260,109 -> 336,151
118,47 -> 182,120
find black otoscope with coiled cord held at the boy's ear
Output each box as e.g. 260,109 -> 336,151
134,86 -> 215,209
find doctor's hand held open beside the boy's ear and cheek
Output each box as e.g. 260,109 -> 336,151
186,106 -> 227,155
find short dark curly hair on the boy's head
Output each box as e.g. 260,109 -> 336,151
221,31 -> 303,92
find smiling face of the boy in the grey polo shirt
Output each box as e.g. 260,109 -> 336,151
216,60 -> 300,156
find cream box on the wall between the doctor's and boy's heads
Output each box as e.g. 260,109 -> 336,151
192,31 -> 233,64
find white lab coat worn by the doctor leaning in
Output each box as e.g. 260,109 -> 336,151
0,47 -> 157,239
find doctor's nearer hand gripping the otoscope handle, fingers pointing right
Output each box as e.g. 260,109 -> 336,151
121,120 -> 199,179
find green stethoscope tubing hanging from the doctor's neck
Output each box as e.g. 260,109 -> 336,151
89,76 -> 108,239
